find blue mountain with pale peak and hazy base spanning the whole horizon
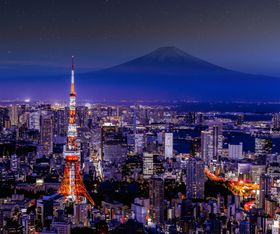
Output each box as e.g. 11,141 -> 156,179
0,47 -> 280,101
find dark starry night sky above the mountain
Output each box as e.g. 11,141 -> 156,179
0,0 -> 280,79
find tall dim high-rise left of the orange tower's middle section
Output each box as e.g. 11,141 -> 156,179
40,114 -> 53,155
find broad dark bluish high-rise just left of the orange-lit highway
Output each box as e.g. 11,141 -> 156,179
185,158 -> 205,198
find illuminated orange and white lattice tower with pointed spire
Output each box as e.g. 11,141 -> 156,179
59,57 -> 94,205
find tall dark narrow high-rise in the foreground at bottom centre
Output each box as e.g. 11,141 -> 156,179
149,177 -> 164,224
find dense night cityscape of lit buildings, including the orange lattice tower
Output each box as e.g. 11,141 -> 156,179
0,66 -> 280,234
